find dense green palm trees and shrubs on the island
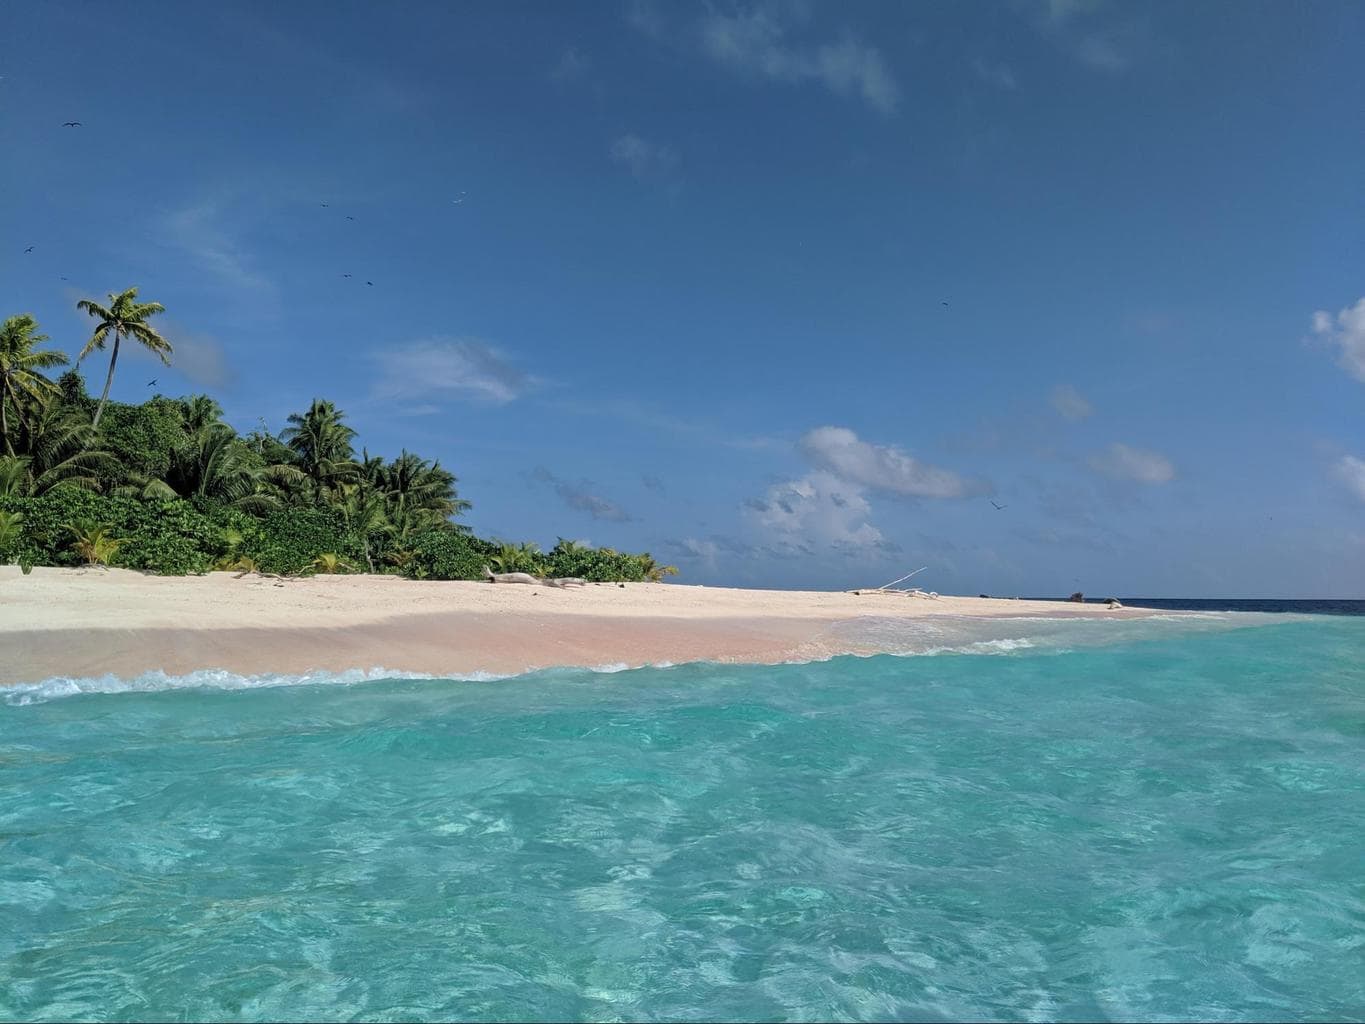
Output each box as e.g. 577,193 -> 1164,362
0,296 -> 677,582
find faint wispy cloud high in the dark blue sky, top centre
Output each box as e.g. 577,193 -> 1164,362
702,10 -> 901,113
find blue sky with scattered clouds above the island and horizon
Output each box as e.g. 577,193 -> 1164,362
0,0 -> 1365,597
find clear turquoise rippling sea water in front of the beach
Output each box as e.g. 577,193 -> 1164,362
0,620 -> 1365,1020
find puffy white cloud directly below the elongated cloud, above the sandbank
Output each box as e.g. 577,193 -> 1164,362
745,471 -> 891,553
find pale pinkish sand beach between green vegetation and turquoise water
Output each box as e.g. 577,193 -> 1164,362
0,567 -> 1151,684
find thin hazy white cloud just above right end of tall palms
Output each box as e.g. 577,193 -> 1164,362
374,337 -> 535,404
